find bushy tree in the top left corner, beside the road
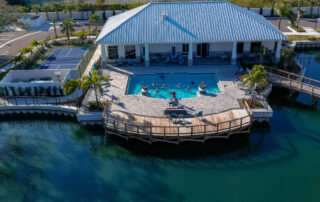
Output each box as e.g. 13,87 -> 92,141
0,0 -> 27,31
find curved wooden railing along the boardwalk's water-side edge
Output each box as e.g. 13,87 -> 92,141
103,102 -> 252,143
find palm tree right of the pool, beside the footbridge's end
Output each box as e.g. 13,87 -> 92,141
241,65 -> 269,105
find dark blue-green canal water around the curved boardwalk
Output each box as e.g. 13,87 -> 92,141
0,52 -> 320,202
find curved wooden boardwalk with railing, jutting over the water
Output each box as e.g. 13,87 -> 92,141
103,105 -> 252,144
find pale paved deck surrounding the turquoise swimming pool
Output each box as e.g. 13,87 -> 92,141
99,65 -> 249,117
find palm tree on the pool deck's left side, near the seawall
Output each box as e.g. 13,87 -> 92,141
81,70 -> 109,108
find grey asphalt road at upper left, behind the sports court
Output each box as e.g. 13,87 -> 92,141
0,24 -> 102,64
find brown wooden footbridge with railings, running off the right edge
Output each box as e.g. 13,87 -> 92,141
265,67 -> 320,97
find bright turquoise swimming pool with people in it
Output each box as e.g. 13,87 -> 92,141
127,73 -> 220,99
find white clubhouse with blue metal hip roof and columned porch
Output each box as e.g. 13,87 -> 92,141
96,2 -> 288,67
